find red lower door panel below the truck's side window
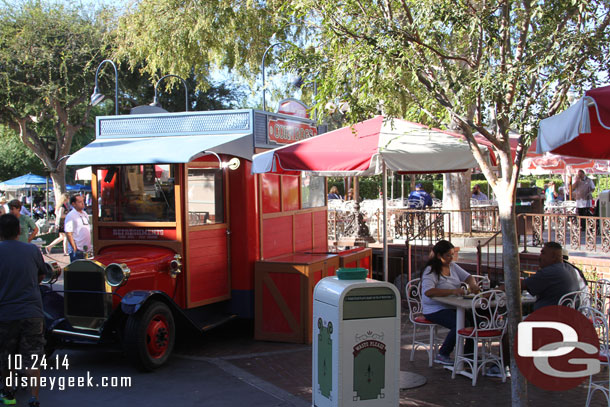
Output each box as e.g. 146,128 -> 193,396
187,228 -> 230,306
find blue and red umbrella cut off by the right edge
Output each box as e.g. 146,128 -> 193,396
536,86 -> 610,159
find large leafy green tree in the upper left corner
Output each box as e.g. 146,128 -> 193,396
0,1 -> 111,209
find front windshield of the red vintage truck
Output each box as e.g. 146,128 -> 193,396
97,164 -> 176,222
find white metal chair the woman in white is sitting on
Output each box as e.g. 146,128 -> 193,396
405,278 -> 439,367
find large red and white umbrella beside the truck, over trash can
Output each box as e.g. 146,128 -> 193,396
252,116 -> 478,176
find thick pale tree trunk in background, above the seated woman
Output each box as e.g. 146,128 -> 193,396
443,171 -> 472,233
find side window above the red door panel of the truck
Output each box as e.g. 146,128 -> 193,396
187,168 -> 224,226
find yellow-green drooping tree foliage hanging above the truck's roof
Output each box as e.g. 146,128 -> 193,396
115,0 -> 302,90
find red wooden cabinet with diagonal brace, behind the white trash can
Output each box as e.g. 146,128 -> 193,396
254,253 -> 339,343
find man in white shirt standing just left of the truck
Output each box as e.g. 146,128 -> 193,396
64,195 -> 91,262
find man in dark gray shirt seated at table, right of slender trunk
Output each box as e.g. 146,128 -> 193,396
521,242 -> 579,311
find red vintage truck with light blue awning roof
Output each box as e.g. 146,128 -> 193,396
43,100 -> 356,370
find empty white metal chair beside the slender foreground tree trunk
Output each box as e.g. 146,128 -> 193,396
451,290 -> 508,386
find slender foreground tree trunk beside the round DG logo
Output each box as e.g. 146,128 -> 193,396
496,196 -> 528,407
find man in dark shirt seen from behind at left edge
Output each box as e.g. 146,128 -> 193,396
0,215 -> 45,407
